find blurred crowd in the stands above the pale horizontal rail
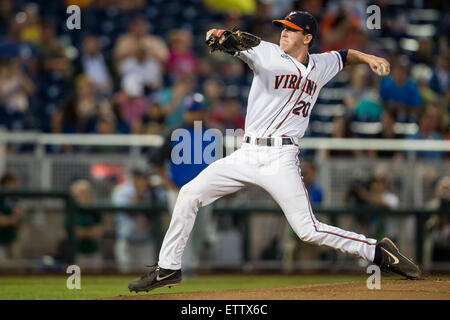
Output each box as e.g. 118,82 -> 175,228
0,0 -> 450,157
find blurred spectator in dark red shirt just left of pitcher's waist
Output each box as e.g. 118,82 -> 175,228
208,95 -> 245,134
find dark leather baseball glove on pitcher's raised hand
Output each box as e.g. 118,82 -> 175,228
206,27 -> 261,53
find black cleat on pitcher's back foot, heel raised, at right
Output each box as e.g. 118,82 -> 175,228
377,238 -> 421,280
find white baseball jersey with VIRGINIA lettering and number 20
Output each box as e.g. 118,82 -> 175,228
236,41 -> 343,138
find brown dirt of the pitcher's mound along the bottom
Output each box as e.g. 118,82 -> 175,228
102,279 -> 450,300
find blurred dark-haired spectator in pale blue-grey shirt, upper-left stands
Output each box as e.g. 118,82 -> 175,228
75,34 -> 113,95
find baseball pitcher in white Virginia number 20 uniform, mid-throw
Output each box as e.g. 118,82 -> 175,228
128,11 -> 421,292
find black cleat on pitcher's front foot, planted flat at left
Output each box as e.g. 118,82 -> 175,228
128,265 -> 181,293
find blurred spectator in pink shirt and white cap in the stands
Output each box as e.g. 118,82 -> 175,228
115,74 -> 148,134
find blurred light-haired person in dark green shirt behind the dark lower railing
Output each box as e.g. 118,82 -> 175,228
70,180 -> 103,271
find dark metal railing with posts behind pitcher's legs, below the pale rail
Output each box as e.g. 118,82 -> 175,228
0,190 -> 449,270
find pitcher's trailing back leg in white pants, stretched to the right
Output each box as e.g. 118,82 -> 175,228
261,153 -> 376,262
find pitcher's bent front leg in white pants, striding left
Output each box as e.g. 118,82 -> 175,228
158,158 -> 251,270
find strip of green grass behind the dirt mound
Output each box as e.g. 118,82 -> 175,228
0,275 -> 442,300
